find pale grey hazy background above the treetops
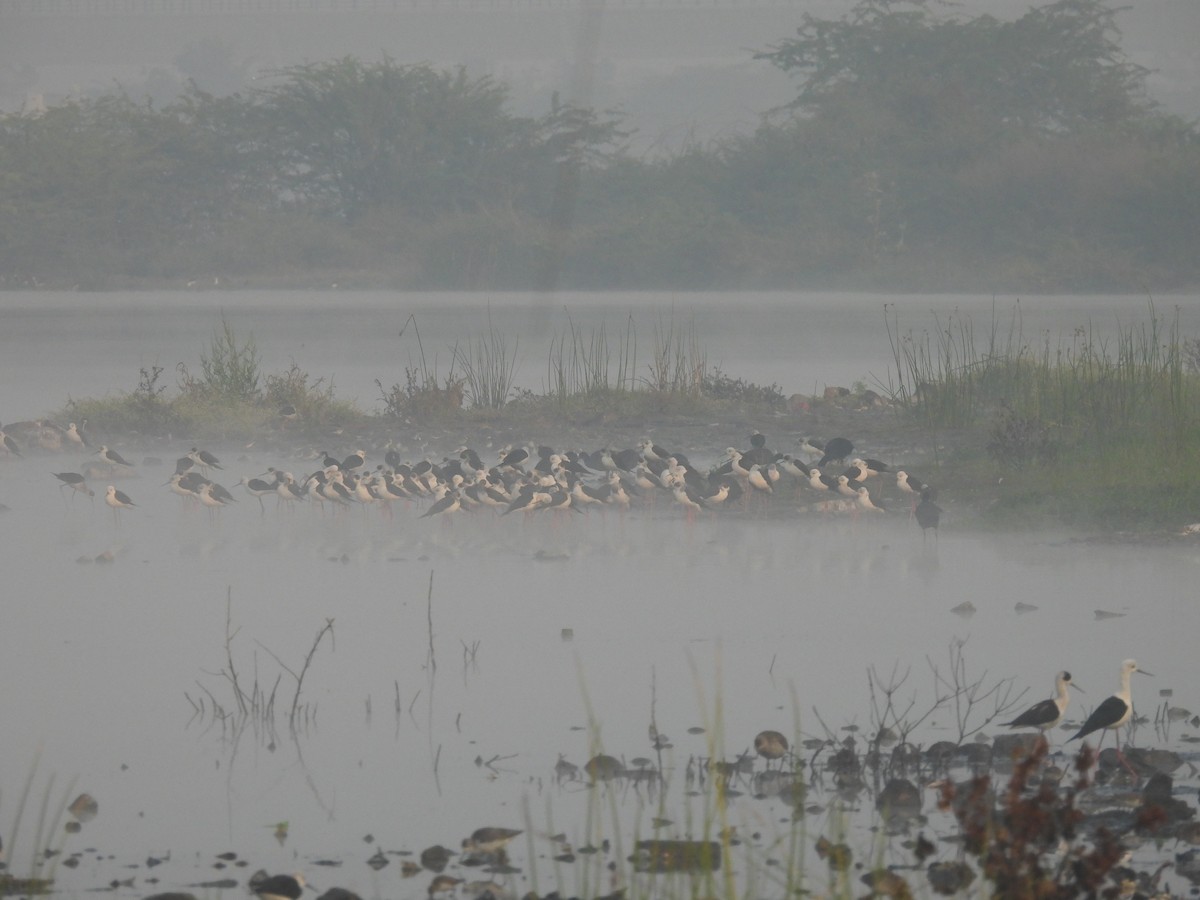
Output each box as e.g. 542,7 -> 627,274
0,0 -> 1200,151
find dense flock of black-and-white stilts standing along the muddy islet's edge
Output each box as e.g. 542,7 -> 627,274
16,422 -> 942,535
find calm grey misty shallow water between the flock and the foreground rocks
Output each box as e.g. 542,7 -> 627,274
0,295 -> 1200,896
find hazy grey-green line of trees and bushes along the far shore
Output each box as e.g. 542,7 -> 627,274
0,0 -> 1200,292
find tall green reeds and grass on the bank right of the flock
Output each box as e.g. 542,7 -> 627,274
883,301 -> 1200,528
